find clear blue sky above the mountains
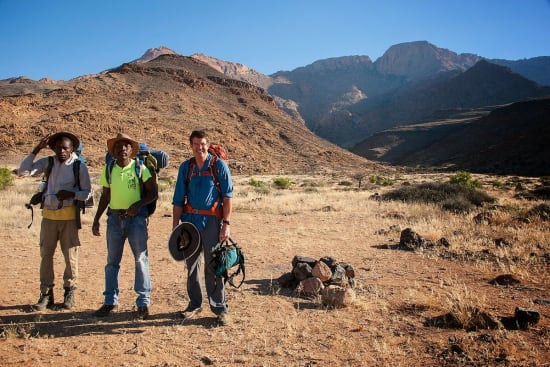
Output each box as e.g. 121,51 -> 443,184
0,0 -> 550,80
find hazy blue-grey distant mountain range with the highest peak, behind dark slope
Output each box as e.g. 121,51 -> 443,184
268,41 -> 548,148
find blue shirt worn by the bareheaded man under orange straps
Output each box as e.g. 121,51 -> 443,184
172,153 -> 233,231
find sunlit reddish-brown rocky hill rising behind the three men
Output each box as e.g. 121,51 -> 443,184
0,54 -> 382,174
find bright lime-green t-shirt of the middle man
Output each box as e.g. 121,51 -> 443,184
99,159 -> 151,210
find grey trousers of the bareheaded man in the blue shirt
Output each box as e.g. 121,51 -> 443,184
185,216 -> 227,315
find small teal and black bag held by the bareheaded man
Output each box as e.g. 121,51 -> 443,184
210,238 -> 245,288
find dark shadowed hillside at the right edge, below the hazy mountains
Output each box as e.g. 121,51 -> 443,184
354,98 -> 550,176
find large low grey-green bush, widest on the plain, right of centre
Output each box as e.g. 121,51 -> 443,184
382,183 -> 496,213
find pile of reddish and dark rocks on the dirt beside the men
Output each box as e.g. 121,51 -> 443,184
278,256 -> 355,307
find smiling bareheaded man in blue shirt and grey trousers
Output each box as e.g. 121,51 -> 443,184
172,130 -> 233,325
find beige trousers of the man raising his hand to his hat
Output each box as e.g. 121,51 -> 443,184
40,218 -> 80,293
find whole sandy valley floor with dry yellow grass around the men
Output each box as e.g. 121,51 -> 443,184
0,167 -> 550,367
